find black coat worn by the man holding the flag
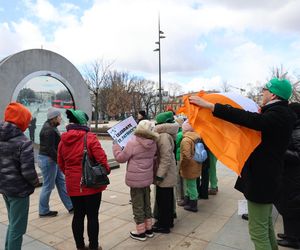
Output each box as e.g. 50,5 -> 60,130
213,101 -> 296,203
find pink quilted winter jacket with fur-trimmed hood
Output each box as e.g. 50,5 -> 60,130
113,129 -> 158,188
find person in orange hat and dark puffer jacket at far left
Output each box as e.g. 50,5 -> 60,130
0,102 -> 39,250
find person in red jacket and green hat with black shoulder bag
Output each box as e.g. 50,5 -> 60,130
57,109 -> 110,250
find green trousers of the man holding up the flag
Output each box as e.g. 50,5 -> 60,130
248,200 -> 278,250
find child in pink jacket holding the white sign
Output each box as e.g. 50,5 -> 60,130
113,120 -> 159,241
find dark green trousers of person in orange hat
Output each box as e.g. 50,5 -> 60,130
3,195 -> 29,250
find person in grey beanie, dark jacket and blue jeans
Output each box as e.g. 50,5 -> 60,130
38,108 -> 73,217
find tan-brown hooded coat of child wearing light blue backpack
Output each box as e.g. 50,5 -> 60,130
179,132 -> 202,179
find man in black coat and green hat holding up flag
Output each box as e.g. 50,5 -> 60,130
190,78 -> 296,250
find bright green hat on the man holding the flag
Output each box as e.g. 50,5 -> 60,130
265,78 -> 292,100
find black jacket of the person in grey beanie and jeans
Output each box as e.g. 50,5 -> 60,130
39,121 -> 60,162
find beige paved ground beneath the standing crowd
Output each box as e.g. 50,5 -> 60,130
0,141 -> 287,250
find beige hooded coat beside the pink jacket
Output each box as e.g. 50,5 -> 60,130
154,123 -> 179,187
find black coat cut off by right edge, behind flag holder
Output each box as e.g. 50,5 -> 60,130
276,120 -> 300,219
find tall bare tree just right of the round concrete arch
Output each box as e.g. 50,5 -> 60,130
84,59 -> 113,128
